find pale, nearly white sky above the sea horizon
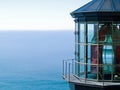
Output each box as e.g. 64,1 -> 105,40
0,0 -> 91,30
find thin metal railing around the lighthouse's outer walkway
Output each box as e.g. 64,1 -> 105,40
62,59 -> 120,86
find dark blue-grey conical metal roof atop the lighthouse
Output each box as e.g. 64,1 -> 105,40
71,0 -> 120,21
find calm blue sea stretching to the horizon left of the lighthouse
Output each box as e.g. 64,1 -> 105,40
0,30 -> 74,90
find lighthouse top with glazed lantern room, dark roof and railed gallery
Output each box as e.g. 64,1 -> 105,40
63,0 -> 120,90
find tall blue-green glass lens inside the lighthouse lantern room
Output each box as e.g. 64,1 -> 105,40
102,35 -> 114,74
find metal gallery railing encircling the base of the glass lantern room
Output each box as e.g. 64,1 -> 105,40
62,59 -> 120,86
